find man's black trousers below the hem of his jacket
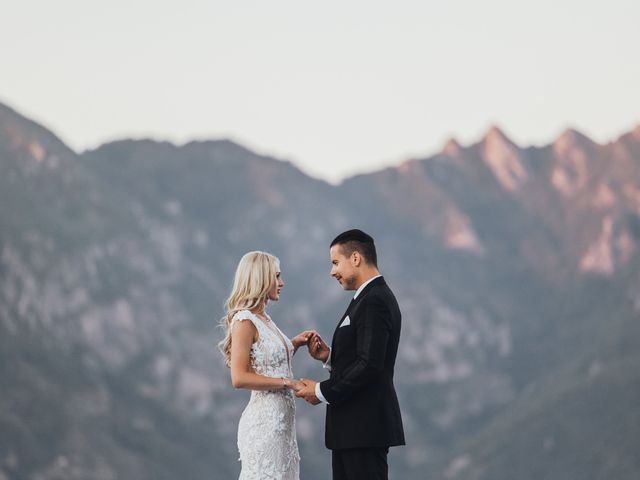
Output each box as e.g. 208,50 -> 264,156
331,447 -> 389,480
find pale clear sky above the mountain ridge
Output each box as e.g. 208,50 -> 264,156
0,0 -> 640,182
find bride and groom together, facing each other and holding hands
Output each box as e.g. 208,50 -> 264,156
220,230 -> 404,480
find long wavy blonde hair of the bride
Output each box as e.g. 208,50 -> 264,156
218,251 -> 280,366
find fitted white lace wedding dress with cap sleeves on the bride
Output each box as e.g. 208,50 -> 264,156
233,310 -> 300,480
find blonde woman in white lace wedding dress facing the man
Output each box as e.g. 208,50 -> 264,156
220,252 -> 314,480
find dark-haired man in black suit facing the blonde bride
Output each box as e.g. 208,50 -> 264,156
296,230 -> 405,480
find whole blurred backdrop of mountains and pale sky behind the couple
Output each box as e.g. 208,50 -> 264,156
0,0 -> 640,480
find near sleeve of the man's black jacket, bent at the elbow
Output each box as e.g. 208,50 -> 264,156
320,295 -> 391,405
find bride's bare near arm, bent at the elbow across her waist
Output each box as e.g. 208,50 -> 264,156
231,321 -> 295,390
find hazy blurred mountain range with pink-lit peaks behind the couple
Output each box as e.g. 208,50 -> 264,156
0,100 -> 640,480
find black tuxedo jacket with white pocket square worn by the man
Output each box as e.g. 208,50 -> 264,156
320,277 -> 404,450
